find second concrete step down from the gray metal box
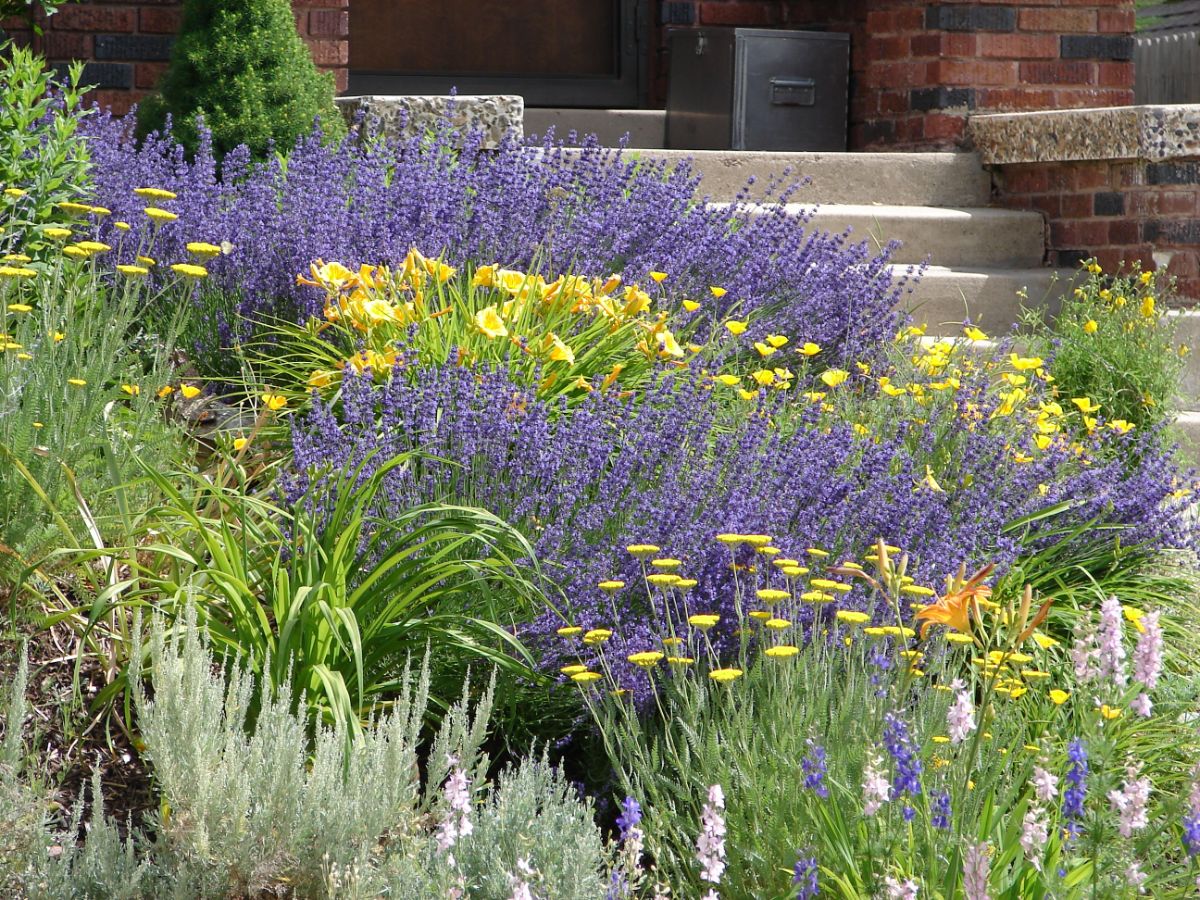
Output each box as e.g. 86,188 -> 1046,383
713,203 -> 1045,269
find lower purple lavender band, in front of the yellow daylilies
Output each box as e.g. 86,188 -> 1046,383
284,366 -> 1194,700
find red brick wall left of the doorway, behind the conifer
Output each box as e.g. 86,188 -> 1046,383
0,0 -> 349,114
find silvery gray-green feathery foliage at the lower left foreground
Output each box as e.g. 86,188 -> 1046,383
0,611 -> 608,900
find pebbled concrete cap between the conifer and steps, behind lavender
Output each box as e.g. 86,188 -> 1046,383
337,95 -> 524,150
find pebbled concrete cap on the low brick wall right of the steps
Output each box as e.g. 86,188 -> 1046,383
967,103 -> 1200,166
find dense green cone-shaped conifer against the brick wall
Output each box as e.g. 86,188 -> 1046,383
138,0 -> 346,158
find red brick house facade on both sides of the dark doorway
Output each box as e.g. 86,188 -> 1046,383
4,0 -> 1134,149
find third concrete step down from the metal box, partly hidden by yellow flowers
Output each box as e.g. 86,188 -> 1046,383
892,265 -> 1076,335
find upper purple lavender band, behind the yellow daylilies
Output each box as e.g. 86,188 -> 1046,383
85,115 -> 901,359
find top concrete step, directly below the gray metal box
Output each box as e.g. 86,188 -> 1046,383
631,150 -> 991,206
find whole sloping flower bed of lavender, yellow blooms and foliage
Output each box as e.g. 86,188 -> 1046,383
0,82 -> 1200,900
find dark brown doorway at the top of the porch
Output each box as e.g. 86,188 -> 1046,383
349,0 -> 647,107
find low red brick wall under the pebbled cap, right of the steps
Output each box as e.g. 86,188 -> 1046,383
992,160 -> 1200,302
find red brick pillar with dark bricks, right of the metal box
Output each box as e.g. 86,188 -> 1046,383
851,0 -> 1134,149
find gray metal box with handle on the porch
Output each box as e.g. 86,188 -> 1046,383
666,28 -> 850,150
